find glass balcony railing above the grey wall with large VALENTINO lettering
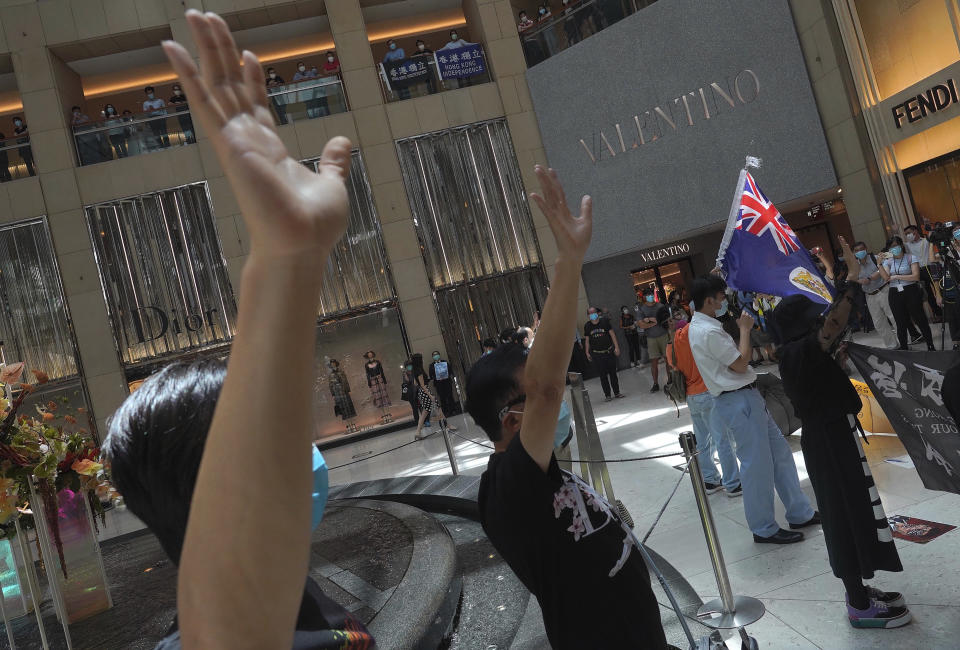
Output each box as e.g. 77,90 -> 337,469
520,0 -> 656,68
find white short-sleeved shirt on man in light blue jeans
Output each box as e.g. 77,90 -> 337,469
690,311 -> 757,397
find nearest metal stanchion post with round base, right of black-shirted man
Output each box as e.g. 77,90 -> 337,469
680,431 -> 766,630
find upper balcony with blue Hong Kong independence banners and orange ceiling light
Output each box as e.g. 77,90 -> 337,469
363,2 -> 492,103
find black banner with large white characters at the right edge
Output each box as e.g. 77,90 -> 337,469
847,343 -> 960,494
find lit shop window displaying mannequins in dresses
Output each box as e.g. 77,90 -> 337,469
314,305 -> 413,439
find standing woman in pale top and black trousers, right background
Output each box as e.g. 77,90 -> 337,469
880,235 -> 934,350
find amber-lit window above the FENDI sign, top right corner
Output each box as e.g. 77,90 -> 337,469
854,0 -> 960,100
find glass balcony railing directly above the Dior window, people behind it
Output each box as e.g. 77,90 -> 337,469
73,104 -> 197,166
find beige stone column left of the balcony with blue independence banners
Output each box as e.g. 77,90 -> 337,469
325,0 -> 444,355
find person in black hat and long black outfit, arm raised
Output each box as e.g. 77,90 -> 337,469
773,237 -> 911,628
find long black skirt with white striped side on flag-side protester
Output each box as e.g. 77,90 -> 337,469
800,415 -> 903,579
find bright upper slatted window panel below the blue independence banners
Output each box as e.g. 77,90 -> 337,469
397,120 -> 540,289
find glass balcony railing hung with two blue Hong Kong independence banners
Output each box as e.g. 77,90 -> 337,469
377,43 -> 490,102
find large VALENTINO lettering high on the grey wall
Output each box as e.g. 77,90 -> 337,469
580,69 -> 760,163
